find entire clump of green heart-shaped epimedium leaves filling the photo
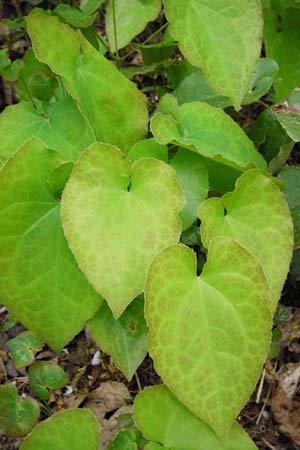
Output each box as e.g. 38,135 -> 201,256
0,0 -> 300,450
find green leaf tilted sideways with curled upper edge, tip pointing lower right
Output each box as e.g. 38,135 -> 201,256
151,94 -> 267,171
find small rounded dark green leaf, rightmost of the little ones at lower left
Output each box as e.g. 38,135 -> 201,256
28,361 -> 67,400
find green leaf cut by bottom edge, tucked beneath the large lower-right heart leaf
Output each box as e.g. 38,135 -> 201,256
134,385 -> 256,450
